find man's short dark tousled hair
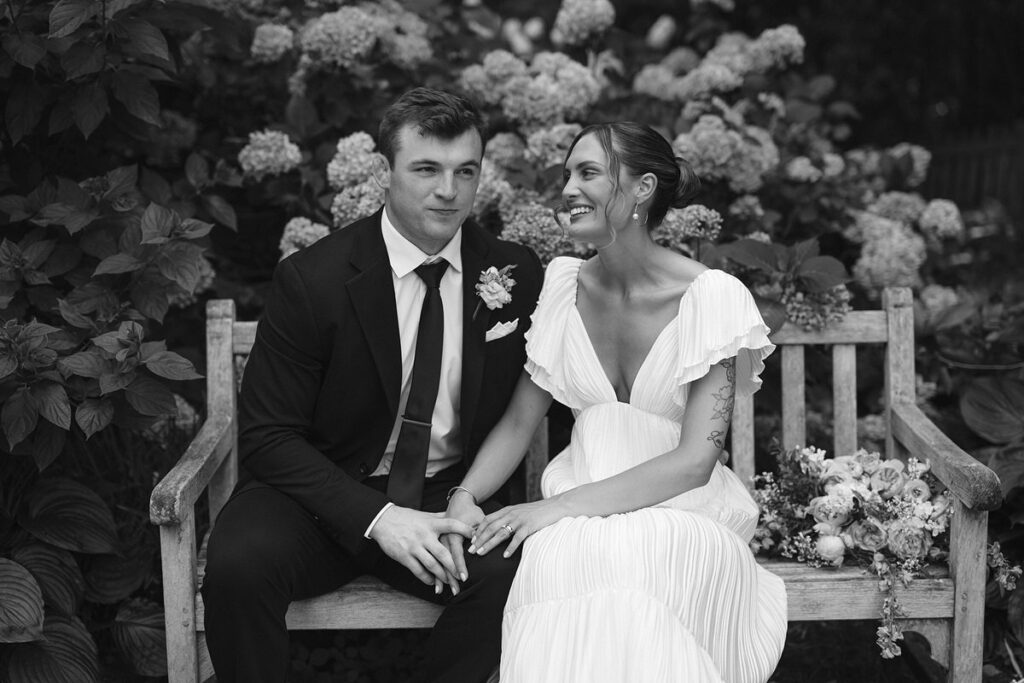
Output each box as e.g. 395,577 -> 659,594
377,88 -> 486,164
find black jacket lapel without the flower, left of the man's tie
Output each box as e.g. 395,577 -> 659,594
346,212 -> 401,415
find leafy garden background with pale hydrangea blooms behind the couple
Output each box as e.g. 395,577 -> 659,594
0,0 -> 1024,681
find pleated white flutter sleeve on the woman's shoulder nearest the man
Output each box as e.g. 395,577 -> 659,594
525,256 -> 582,408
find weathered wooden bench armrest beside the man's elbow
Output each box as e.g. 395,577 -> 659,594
150,414 -> 234,526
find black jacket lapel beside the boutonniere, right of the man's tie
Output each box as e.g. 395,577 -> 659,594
460,224 -> 490,457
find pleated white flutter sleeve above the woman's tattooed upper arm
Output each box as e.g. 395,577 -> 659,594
674,270 -> 775,405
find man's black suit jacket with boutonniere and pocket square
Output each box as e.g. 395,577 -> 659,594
239,211 -> 544,553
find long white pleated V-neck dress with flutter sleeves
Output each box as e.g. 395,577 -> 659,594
501,258 -> 786,683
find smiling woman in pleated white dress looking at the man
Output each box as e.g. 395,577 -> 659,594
445,123 -> 786,683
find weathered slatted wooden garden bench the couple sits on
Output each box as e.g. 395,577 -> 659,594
150,289 -> 1001,683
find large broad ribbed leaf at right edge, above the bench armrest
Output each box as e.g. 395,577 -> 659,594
959,377 -> 1024,443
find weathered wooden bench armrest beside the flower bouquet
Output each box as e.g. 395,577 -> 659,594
890,402 -> 1002,510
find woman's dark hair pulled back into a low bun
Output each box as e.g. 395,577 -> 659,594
565,121 -> 700,229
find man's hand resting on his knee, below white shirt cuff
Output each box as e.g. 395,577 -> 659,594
370,505 -> 473,593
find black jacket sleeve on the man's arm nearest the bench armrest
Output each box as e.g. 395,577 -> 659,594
239,259 -> 388,553
